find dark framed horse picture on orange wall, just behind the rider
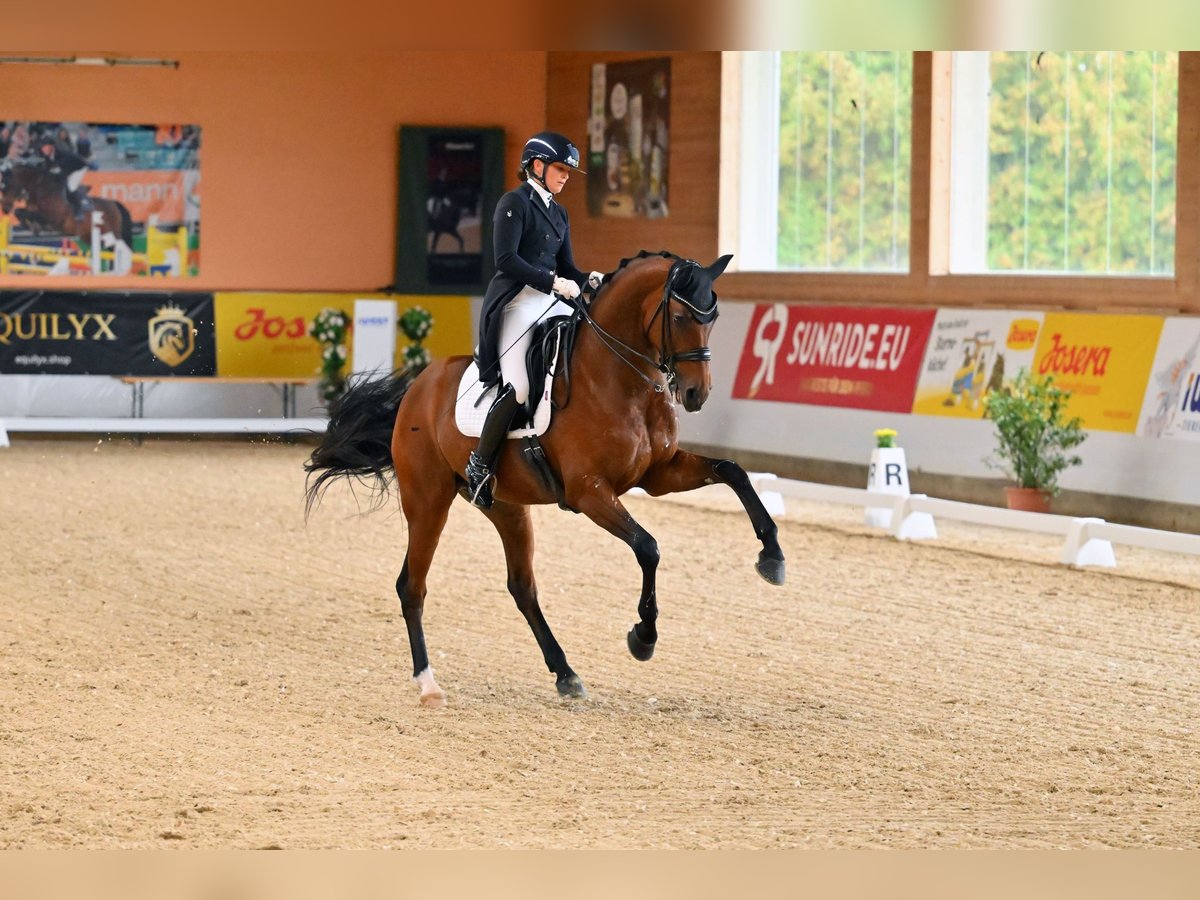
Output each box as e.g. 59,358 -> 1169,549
394,125 -> 504,294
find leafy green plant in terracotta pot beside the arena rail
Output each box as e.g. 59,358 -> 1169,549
984,368 -> 1087,512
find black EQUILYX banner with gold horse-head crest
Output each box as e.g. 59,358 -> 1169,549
0,290 -> 216,376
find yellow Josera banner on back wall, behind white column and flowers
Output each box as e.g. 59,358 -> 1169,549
214,292 -> 475,378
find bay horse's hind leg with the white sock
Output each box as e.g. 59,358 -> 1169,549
396,473 -> 455,707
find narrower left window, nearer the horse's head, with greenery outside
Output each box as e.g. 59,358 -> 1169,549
739,50 -> 912,272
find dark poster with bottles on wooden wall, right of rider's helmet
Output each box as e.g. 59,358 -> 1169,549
588,58 -> 671,218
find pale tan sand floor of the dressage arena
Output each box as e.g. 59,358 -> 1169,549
0,439 -> 1200,848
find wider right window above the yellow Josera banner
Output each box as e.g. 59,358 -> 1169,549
950,50 -> 1178,276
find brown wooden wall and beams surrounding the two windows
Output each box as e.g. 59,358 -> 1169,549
546,52 -> 1200,313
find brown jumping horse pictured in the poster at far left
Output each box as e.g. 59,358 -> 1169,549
0,161 -> 133,250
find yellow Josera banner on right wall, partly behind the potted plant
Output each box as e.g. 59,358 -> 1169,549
1033,312 -> 1163,434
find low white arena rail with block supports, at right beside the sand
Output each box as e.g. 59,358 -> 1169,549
630,472 -> 1200,568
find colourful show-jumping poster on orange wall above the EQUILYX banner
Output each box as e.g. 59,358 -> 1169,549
0,119 -> 200,277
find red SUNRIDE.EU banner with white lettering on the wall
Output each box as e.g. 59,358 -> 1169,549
733,304 -> 935,413
